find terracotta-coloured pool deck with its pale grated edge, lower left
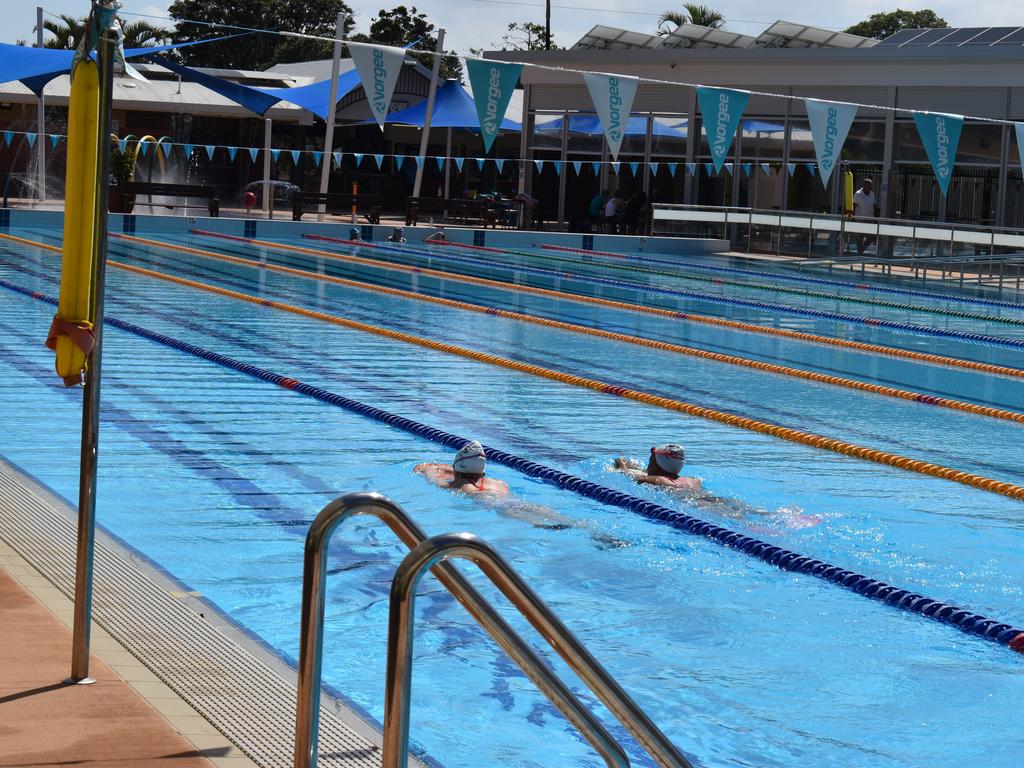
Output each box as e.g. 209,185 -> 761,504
0,459 -> 423,768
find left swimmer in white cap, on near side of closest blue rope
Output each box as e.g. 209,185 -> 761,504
413,440 -> 629,548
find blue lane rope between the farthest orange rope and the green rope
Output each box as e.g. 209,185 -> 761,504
292,241 -> 1024,349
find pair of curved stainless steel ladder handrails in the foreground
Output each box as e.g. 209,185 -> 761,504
294,493 -> 690,768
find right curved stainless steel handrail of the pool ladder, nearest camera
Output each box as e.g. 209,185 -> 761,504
381,534 -> 690,768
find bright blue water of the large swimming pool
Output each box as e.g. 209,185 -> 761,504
0,219 -> 1024,768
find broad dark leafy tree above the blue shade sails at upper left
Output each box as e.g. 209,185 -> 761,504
167,0 -> 355,70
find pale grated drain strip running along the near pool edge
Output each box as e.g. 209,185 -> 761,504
0,459 -> 421,768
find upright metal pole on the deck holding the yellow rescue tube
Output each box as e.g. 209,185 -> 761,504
65,10 -> 119,685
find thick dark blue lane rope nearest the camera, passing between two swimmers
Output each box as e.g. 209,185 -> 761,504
0,279 -> 1024,653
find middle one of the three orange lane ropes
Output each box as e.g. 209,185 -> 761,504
86,238 -> 1024,424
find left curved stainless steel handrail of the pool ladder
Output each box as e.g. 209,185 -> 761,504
293,493 -> 629,768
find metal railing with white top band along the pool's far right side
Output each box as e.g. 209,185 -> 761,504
653,204 -> 1024,290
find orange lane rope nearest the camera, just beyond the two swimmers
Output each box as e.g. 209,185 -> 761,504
18,243 -> 1024,499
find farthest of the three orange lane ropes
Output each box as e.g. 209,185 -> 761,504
178,229 -> 1024,378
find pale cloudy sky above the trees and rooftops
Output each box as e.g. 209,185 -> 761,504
6,0 -> 1024,58
